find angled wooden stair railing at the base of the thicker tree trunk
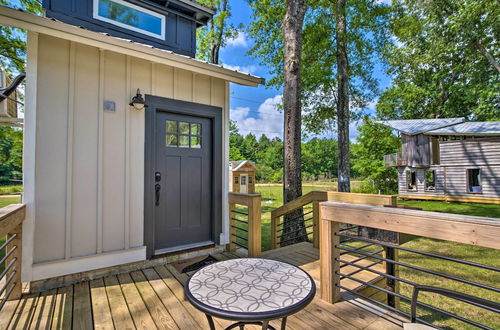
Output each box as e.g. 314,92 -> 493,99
271,191 -> 397,249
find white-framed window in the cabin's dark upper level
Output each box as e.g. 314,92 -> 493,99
94,0 -> 165,39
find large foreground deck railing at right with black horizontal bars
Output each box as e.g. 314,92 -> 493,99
320,202 -> 500,328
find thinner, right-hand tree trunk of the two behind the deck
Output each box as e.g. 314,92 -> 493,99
336,0 -> 351,192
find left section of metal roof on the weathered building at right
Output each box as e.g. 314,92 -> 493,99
377,118 -> 465,135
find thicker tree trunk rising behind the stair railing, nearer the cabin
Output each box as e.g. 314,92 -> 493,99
281,0 -> 307,245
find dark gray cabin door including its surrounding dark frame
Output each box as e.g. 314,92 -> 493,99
144,95 -> 223,257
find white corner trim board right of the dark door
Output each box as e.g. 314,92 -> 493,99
220,81 -> 231,244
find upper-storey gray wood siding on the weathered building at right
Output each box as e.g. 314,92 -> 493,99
440,137 -> 500,166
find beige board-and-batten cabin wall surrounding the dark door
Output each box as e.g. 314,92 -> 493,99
25,33 -> 229,280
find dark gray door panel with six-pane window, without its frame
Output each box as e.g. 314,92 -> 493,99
154,111 -> 213,253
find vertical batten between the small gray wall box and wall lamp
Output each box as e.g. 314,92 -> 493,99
123,55 -> 131,249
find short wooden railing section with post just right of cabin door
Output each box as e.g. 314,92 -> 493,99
229,192 -> 262,258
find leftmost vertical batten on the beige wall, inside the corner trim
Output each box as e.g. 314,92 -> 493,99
64,41 -> 76,259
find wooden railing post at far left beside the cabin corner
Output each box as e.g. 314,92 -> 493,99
5,223 -> 23,300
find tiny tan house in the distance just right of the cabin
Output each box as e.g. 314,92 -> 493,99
229,160 -> 257,194
